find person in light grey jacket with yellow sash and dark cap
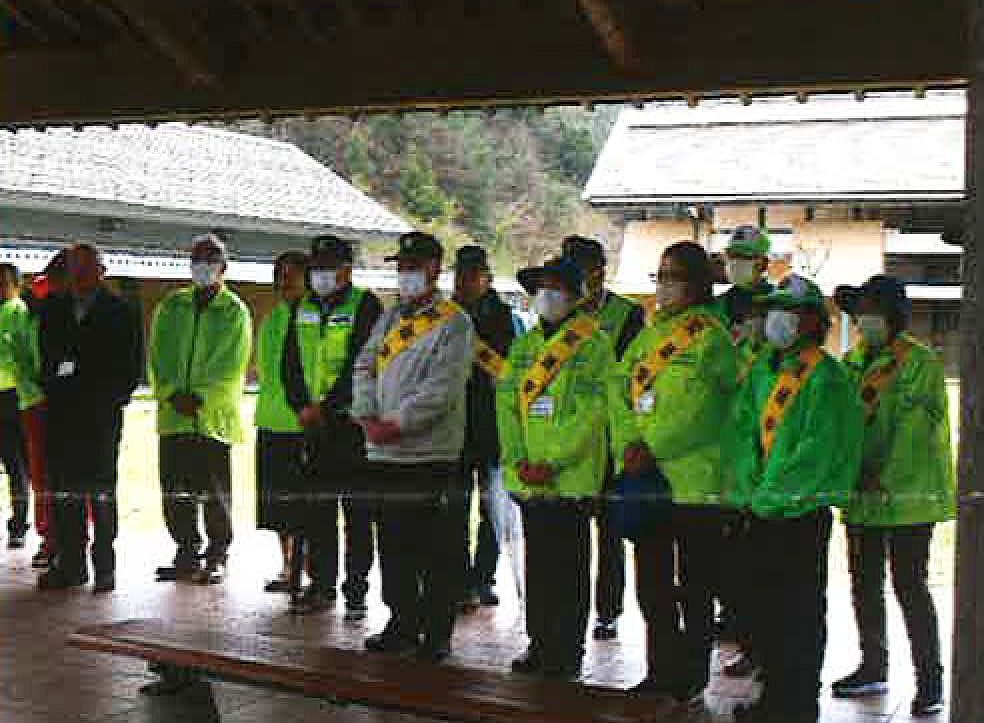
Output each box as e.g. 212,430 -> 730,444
351,231 -> 474,661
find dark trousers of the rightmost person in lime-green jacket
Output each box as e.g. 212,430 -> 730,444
847,524 -> 942,681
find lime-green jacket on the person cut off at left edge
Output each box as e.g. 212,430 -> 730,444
0,298 -> 43,409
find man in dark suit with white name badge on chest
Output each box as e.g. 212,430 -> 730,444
38,244 -> 143,592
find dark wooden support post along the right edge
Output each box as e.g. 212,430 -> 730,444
944,0 -> 984,723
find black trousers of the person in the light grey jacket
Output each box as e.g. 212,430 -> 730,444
370,462 -> 460,646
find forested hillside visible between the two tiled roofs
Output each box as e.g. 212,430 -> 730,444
227,106 -> 619,273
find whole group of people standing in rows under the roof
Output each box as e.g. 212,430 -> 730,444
0,227 -> 954,723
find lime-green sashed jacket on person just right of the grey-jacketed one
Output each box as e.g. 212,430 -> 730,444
496,314 -> 615,497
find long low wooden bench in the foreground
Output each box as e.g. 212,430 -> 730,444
69,620 -> 672,723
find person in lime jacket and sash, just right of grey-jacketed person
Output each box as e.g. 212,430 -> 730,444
496,258 -> 615,678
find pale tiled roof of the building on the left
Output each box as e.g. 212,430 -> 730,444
0,123 -> 409,237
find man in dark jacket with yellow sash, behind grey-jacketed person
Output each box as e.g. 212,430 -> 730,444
452,246 -> 515,608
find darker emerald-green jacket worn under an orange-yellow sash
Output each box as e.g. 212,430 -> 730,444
722,347 -> 864,517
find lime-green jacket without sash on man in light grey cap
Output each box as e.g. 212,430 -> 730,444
148,286 -> 252,444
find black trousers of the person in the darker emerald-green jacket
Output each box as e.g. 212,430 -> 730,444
737,508 -> 832,721
